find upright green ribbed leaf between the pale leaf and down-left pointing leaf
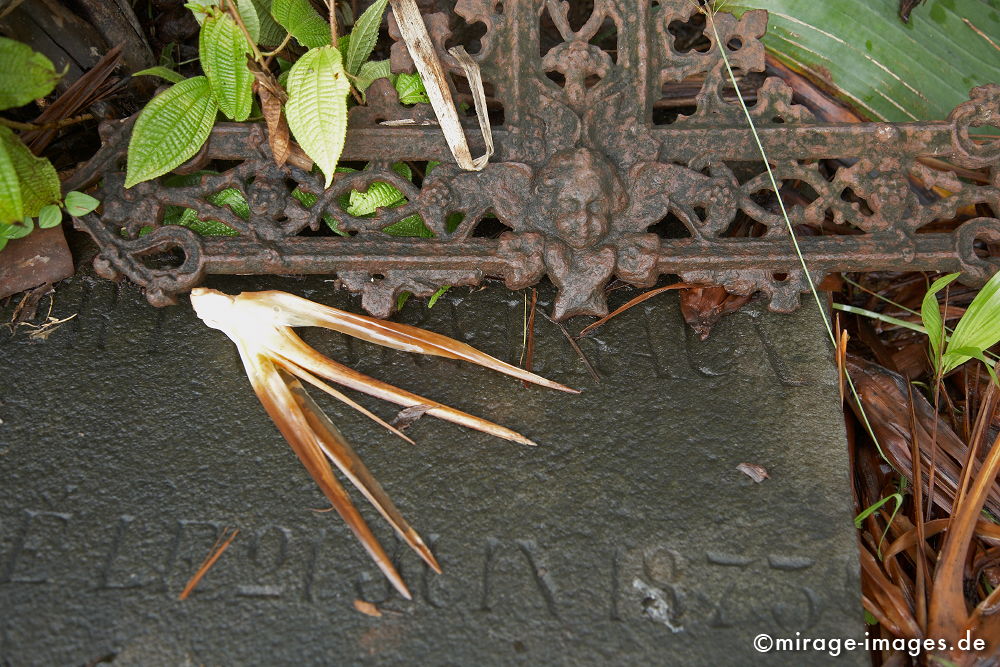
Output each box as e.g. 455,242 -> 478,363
198,14 -> 253,121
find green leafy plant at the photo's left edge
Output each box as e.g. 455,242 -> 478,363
0,37 -> 99,250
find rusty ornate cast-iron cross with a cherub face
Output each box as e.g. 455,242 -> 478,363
75,0 -> 1000,318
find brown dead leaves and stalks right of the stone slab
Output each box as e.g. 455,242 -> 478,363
838,274 -> 1000,665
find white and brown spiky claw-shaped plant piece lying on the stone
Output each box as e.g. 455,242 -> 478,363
191,287 -> 578,599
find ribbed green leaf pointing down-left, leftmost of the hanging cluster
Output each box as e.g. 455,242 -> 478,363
125,76 -> 218,188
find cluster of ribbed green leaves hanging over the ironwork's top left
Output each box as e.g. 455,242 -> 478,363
125,0 -> 427,189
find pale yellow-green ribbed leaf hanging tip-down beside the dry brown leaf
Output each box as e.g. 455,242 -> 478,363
285,46 -> 351,187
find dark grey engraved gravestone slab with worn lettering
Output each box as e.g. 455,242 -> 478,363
0,278 -> 867,665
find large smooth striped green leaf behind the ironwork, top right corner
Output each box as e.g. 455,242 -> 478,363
723,0 -> 1000,122
